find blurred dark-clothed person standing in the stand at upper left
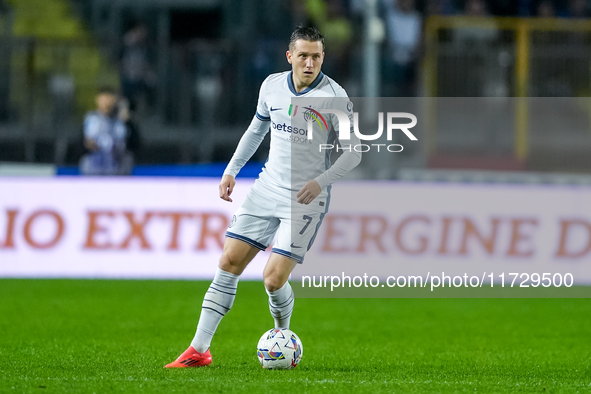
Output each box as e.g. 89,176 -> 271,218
120,23 -> 154,113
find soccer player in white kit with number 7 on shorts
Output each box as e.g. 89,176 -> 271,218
166,25 -> 361,368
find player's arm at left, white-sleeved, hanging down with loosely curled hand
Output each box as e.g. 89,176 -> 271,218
220,81 -> 271,202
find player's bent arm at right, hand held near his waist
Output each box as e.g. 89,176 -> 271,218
297,90 -> 361,204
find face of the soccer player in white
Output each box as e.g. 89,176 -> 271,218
287,40 -> 324,91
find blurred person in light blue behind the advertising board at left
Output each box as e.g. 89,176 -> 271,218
80,88 -> 133,175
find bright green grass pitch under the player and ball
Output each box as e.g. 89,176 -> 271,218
0,279 -> 591,393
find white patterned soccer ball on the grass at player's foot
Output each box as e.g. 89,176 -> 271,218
257,328 -> 304,369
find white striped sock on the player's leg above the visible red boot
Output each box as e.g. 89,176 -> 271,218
191,268 -> 240,353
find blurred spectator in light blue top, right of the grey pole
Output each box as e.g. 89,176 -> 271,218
382,0 -> 423,97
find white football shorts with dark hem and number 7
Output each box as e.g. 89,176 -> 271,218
226,189 -> 324,263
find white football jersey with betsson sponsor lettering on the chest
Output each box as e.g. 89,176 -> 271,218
226,71 -> 361,212
